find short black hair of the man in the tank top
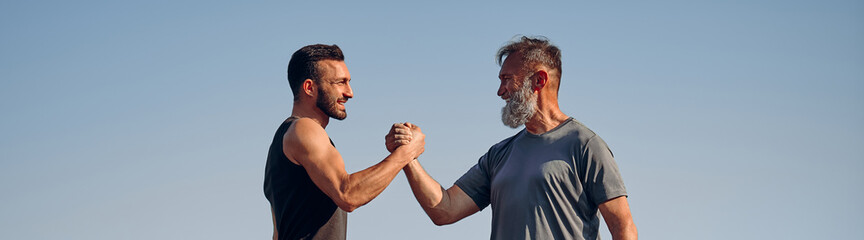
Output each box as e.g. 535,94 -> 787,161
288,44 -> 345,100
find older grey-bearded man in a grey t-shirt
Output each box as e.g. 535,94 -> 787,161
387,37 -> 637,239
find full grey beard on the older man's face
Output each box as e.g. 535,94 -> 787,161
501,81 -> 537,128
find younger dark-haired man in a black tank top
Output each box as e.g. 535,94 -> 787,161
264,44 -> 425,239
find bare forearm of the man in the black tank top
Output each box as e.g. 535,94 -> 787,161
341,146 -> 412,212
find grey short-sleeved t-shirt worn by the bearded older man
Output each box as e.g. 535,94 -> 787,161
456,118 -> 627,240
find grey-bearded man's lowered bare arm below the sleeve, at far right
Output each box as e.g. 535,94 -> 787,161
598,196 -> 638,240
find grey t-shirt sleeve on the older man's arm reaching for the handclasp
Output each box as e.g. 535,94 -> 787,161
456,153 -> 492,210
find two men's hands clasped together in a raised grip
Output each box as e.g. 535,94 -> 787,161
384,122 -> 426,159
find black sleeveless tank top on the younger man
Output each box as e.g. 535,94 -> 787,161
264,117 -> 348,240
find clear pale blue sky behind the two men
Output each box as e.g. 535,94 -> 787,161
0,0 -> 864,239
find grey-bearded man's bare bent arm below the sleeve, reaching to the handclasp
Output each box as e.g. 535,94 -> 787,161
403,160 -> 480,226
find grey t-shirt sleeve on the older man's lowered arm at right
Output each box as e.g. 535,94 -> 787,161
582,136 -> 627,205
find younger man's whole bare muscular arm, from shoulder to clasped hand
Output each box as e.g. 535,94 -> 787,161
283,118 -> 425,212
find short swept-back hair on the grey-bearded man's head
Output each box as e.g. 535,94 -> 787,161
496,36 -> 561,80
